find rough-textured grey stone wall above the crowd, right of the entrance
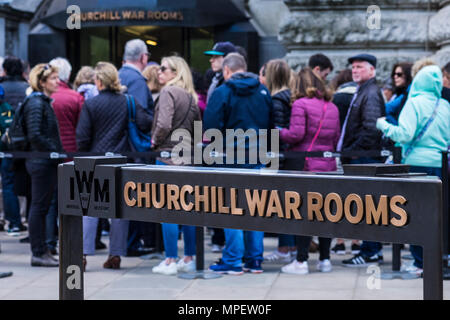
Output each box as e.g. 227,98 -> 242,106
278,0 -> 442,79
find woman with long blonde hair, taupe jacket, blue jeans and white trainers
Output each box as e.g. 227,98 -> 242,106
152,56 -> 201,275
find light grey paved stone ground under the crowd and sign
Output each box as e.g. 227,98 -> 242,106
0,228 -> 450,300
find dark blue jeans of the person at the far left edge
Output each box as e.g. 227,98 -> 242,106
0,158 -> 22,228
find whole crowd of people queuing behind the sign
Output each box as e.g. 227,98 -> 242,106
0,39 -> 450,275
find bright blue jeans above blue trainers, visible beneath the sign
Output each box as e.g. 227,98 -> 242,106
222,229 -> 264,267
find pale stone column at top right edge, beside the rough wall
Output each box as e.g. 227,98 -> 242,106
429,0 -> 450,67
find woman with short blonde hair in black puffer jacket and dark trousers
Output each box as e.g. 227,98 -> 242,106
23,64 -> 64,267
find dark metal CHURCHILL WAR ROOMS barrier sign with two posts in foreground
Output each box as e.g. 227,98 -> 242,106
58,157 -> 443,299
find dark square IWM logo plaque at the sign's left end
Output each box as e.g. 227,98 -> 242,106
58,157 -> 127,218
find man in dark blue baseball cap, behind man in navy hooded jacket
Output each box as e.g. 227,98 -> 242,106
204,41 -> 237,102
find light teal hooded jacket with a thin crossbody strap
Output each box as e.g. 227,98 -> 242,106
377,65 -> 450,168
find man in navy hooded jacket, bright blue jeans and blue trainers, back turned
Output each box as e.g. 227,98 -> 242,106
203,53 -> 272,275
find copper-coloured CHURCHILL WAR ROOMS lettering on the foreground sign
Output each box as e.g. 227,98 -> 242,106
123,181 -> 408,227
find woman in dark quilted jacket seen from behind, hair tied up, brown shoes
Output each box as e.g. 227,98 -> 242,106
76,62 -> 152,269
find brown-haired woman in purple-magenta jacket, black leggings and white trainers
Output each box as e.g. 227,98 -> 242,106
280,68 -> 340,274
